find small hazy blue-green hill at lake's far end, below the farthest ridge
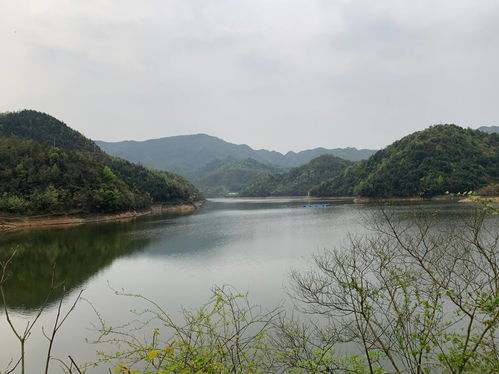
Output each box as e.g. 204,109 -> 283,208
193,158 -> 282,196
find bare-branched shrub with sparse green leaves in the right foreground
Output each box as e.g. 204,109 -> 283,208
293,209 -> 499,374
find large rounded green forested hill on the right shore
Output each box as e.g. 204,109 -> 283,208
311,125 -> 499,197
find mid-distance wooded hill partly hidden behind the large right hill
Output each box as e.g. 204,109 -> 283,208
240,155 -> 352,196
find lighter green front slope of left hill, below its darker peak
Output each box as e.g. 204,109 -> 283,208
0,138 -> 150,214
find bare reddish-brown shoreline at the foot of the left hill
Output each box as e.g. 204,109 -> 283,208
0,200 -> 205,232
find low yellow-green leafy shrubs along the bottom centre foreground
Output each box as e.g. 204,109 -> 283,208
89,286 -> 394,374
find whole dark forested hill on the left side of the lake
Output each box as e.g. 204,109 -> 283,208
0,110 -> 200,215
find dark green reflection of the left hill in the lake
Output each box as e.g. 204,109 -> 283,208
0,221 -> 152,310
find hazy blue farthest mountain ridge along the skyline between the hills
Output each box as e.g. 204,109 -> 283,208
96,134 -> 375,180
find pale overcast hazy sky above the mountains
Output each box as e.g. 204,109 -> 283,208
0,0 -> 499,151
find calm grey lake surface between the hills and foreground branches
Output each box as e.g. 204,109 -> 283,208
0,199 -> 484,372
